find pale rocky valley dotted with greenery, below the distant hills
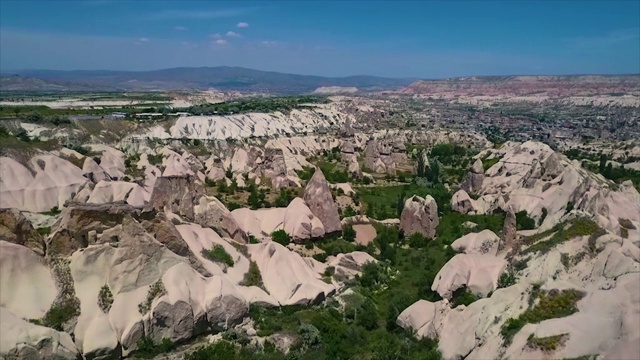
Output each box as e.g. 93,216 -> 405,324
0,76 -> 640,360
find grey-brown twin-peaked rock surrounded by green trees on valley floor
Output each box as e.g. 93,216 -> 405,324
400,195 -> 440,239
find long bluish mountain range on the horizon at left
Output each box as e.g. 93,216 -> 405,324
0,66 -> 415,93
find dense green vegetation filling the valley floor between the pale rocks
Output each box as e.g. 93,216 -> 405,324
172,178 -> 504,360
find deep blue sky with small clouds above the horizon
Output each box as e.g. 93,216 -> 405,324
0,0 -> 640,78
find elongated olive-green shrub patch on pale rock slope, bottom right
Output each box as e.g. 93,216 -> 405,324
500,290 -> 584,345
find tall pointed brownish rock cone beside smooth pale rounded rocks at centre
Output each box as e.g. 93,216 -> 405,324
304,169 -> 342,234
